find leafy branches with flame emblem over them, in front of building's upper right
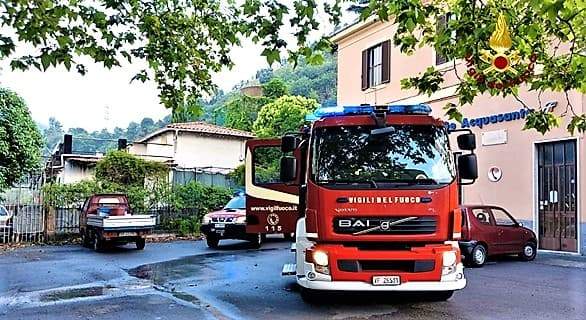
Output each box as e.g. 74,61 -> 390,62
344,0 -> 586,133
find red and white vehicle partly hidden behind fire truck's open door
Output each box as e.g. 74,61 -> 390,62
200,193 -> 264,248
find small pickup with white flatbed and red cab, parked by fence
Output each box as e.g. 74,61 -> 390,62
80,194 -> 156,251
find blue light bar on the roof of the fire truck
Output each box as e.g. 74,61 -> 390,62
305,104 -> 431,121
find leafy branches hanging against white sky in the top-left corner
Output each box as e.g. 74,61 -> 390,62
0,0 -> 244,119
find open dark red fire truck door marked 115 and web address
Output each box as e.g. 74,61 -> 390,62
245,139 -> 299,234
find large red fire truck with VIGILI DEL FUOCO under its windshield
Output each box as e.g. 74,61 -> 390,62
247,105 -> 477,300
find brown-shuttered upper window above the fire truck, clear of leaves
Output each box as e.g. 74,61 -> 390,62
362,40 -> 390,90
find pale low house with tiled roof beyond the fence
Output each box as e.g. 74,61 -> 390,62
129,122 -> 254,173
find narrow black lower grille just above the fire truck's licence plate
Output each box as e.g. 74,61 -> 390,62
338,260 -> 435,273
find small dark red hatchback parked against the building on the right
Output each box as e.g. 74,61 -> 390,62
459,205 -> 537,267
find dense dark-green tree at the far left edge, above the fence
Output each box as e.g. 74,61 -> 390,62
0,89 -> 43,191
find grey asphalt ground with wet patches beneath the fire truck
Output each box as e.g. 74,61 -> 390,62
0,239 -> 586,320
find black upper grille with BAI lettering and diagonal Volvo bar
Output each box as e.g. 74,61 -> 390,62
334,216 -> 437,235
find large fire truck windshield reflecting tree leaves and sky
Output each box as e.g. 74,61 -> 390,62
311,125 -> 455,188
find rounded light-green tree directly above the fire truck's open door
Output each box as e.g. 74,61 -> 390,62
252,96 -> 317,138
